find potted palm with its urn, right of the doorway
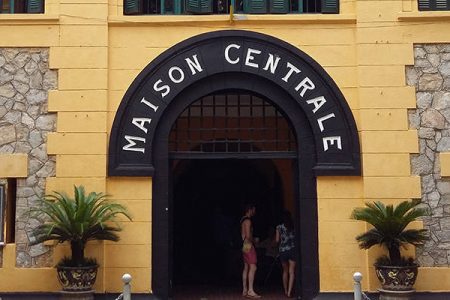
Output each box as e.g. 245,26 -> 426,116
351,200 -> 429,292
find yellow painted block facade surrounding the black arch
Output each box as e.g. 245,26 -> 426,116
0,0 -> 450,292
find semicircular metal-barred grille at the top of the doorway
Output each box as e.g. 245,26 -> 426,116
169,94 -> 296,153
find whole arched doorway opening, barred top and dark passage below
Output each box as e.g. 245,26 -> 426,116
169,91 -> 297,299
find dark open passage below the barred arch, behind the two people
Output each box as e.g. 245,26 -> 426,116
173,159 -> 286,286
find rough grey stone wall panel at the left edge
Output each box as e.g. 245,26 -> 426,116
0,48 -> 57,267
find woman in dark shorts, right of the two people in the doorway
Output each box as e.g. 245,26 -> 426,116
275,211 -> 295,298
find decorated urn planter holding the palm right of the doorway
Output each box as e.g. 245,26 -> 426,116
375,264 -> 418,291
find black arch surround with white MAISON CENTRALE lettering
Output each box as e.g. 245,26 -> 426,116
108,31 -> 360,299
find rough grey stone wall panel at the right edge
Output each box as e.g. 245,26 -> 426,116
406,44 -> 450,266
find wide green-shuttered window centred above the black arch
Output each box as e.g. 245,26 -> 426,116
124,0 -> 339,15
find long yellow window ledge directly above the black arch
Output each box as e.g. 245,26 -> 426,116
108,14 -> 356,26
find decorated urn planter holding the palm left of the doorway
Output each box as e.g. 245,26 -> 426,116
56,265 -> 98,292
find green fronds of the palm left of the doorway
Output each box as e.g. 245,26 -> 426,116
27,186 -> 131,264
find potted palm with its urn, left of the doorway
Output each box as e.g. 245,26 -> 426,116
28,186 -> 131,292
